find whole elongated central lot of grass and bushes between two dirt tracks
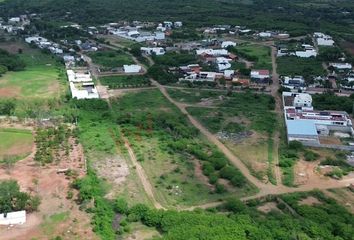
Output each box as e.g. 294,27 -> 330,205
112,90 -> 254,206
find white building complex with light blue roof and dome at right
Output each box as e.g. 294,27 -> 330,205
283,92 -> 354,147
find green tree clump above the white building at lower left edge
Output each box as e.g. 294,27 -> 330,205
0,180 -> 40,213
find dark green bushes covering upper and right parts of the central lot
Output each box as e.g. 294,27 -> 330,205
112,90 -> 249,202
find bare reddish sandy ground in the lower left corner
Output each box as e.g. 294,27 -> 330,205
0,133 -> 97,240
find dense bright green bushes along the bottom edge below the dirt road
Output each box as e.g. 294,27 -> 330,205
83,192 -> 354,240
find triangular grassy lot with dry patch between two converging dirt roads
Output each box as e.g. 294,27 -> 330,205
169,89 -> 276,181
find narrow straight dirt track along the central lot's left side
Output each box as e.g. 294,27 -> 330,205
122,136 -> 165,209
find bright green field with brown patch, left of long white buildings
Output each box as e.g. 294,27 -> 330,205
0,44 -> 66,99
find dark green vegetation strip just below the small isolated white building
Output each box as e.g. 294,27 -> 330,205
100,75 -> 151,89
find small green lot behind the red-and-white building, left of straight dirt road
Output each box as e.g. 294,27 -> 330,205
236,44 -> 272,70
